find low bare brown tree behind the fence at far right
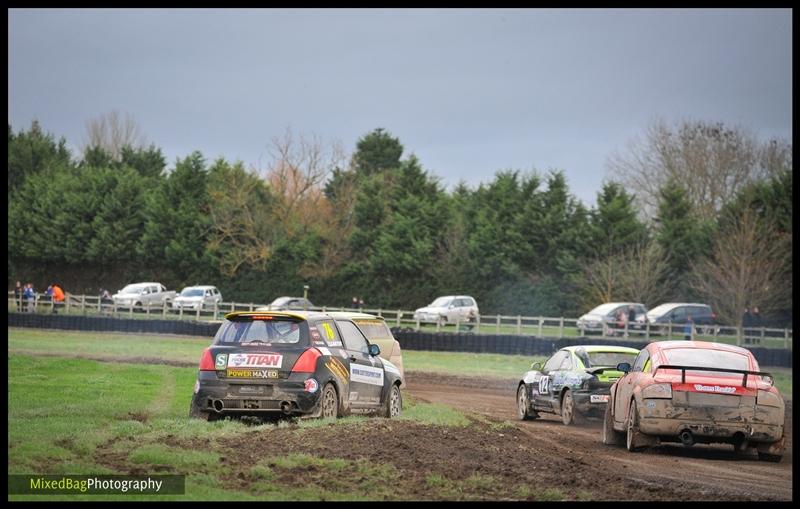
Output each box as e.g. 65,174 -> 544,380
692,207 -> 792,324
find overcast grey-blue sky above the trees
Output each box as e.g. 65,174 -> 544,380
8,9 -> 792,205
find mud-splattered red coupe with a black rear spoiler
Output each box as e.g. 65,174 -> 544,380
603,341 -> 785,461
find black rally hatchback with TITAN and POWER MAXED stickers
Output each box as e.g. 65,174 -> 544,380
189,311 -> 402,420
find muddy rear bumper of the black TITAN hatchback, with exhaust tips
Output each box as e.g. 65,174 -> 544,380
194,372 -> 321,415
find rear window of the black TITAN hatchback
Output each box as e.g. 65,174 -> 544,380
214,316 -> 308,346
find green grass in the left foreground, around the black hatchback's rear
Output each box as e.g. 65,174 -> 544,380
8,354 -> 479,500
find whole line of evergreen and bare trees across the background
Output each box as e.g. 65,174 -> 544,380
8,120 -> 792,325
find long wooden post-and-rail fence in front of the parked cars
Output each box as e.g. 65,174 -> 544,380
8,292 -> 792,349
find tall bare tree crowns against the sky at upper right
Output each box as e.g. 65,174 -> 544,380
606,120 -> 792,219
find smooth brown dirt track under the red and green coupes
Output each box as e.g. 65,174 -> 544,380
407,372 -> 792,500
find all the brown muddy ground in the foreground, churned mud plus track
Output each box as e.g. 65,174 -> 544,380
90,372 -> 792,501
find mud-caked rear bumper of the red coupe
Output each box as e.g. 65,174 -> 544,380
639,399 -> 784,443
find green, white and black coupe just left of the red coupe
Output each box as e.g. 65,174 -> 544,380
517,345 -> 639,425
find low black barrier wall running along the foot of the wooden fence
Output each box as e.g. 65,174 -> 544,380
8,312 -> 792,367
